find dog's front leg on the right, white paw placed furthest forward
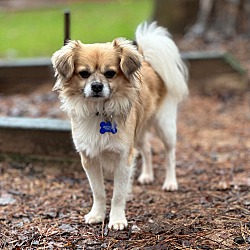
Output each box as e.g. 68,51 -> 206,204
108,152 -> 133,230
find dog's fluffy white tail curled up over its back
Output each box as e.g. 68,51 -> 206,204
136,22 -> 188,102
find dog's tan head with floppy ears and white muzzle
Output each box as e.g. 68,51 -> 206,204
52,39 -> 142,101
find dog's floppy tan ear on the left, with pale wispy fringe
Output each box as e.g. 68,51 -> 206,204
51,41 -> 79,90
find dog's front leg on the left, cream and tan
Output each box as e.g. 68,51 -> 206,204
80,153 -> 106,224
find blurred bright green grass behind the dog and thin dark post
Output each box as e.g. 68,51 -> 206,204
0,0 -> 153,58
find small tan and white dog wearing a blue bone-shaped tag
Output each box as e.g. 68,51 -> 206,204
52,23 -> 188,230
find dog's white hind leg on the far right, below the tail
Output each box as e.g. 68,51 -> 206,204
156,97 -> 178,191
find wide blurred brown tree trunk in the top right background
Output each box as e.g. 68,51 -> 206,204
153,0 -> 250,38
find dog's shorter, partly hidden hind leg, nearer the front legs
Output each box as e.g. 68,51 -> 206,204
138,132 -> 154,184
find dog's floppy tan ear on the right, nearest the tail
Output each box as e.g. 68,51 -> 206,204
113,38 -> 142,79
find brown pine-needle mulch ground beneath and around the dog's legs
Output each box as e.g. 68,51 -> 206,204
0,90 -> 250,250
